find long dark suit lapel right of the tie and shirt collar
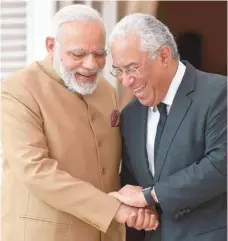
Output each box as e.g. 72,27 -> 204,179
154,63 -> 195,181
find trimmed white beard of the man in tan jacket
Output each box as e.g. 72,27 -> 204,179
53,48 -> 98,95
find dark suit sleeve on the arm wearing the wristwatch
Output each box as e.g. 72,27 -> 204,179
154,82 -> 227,216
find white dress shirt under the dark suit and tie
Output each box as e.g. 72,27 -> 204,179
147,61 -> 186,176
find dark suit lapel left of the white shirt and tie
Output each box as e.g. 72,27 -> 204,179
134,100 -> 153,187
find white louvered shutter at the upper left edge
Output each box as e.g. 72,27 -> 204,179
0,0 -> 27,79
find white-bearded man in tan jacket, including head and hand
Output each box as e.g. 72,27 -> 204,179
1,5 -> 158,241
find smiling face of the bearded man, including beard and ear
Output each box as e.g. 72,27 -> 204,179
51,18 -> 106,95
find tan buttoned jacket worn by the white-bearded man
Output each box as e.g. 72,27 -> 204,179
1,58 -> 124,241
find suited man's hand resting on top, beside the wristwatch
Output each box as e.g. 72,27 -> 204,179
109,185 -> 148,208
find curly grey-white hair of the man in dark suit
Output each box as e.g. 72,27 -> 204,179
109,13 -> 179,59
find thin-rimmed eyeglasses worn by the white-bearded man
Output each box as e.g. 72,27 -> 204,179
55,39 -> 107,60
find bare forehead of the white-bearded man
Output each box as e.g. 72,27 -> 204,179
59,21 -> 105,50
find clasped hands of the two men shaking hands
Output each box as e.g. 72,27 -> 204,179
109,185 -> 159,231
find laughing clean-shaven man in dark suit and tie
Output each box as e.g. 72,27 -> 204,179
110,14 -> 227,241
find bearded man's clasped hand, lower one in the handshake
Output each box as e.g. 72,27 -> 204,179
115,204 -> 159,231
